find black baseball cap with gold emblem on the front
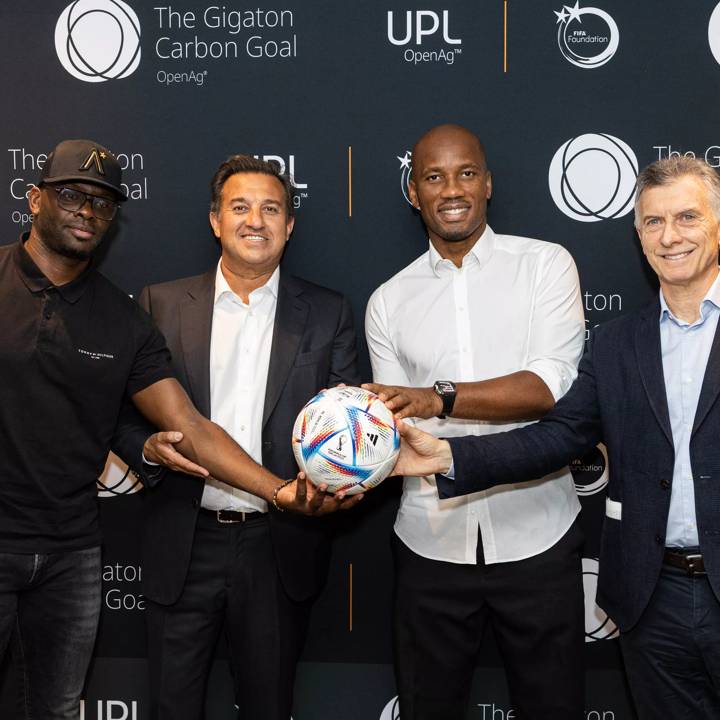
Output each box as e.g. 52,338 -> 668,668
40,140 -> 127,201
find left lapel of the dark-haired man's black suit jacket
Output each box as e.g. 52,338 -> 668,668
178,268 -> 216,418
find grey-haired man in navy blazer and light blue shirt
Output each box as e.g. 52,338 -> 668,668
394,157 -> 720,720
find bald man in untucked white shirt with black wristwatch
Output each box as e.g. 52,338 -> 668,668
365,125 -> 584,720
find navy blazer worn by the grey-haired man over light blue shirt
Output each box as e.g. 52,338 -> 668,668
439,301 -> 720,631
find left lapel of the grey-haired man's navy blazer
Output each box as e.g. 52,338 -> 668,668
635,302 -> 673,445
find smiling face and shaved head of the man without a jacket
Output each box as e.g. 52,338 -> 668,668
409,125 -> 492,255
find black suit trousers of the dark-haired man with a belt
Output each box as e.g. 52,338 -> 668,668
146,512 -> 310,720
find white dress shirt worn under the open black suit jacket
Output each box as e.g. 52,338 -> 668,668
201,260 -> 282,512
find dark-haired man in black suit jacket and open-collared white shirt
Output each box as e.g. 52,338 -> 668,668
128,155 -> 359,720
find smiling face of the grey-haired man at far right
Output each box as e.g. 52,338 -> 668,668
638,175 -> 720,296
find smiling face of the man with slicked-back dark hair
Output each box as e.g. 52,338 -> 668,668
210,172 -> 294,277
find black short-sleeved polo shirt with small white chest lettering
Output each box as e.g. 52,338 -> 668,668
0,235 -> 173,553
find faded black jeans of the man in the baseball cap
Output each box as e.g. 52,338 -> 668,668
0,547 -> 101,720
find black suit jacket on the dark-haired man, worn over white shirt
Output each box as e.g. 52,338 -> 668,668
130,268 -> 360,604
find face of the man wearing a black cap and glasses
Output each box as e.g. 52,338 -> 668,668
28,183 -> 116,260
